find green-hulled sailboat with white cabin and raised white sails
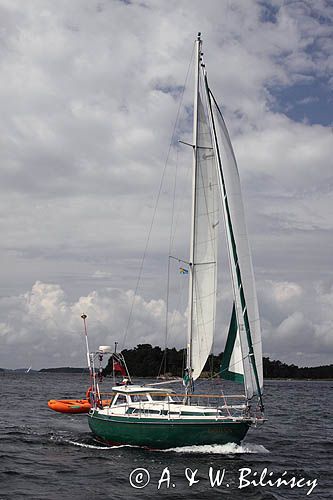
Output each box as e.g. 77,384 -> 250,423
88,33 -> 264,449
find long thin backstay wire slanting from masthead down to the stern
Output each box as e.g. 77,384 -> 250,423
122,41 -> 195,348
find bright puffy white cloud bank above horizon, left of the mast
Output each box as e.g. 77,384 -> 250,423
0,281 -> 186,369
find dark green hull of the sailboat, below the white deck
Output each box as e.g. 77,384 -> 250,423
88,411 -> 250,449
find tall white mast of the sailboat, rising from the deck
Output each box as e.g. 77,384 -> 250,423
185,32 -> 202,392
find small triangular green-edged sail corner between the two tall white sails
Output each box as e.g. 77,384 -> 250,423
220,304 -> 244,383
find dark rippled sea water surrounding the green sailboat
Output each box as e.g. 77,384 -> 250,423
0,372 -> 333,500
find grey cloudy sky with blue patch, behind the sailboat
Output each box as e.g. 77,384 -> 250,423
0,0 -> 333,369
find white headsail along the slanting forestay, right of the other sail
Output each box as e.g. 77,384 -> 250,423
212,101 -> 263,398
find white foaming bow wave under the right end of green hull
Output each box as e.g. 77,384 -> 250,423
161,443 -> 269,455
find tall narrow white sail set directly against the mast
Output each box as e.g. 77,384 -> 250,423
189,95 -> 219,380
